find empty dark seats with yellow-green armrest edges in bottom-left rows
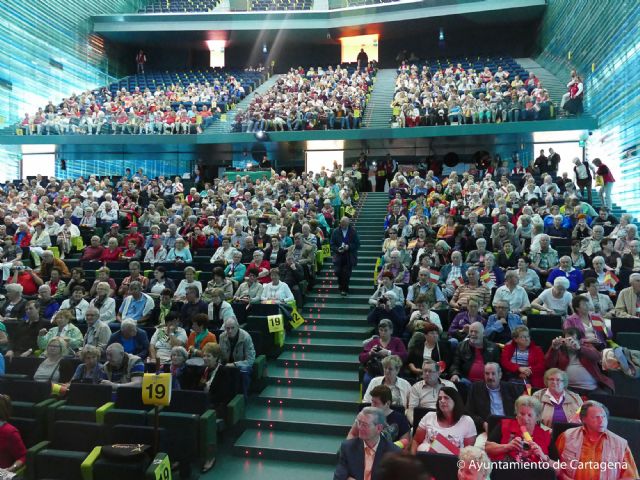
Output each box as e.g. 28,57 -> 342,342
0,376 -> 222,480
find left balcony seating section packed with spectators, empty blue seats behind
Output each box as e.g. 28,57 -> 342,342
16,68 -> 266,135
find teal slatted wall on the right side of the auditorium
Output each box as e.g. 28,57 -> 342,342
537,0 -> 640,216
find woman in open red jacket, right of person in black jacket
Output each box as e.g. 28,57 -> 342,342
500,325 -> 544,388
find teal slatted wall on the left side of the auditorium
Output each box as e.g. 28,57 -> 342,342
0,0 -> 141,178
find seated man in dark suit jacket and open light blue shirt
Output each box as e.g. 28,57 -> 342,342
467,362 -> 524,433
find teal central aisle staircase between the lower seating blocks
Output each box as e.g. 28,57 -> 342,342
220,193 -> 388,480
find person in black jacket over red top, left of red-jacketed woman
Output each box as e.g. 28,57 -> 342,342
450,322 -> 500,385
